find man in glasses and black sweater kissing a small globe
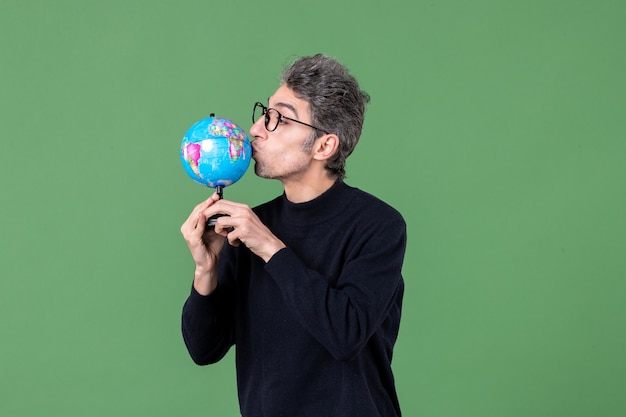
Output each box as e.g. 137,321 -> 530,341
181,55 -> 406,417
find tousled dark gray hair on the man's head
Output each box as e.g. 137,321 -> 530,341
280,54 -> 370,179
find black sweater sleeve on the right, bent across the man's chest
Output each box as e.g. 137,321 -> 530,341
266,219 -> 406,360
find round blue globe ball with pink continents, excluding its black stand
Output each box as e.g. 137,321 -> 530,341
180,117 -> 252,188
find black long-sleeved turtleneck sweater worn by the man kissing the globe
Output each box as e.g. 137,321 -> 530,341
182,182 -> 406,417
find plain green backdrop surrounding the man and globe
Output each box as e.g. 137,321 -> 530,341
0,0 -> 626,417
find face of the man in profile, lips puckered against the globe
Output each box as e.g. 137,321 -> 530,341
250,85 -> 315,180
